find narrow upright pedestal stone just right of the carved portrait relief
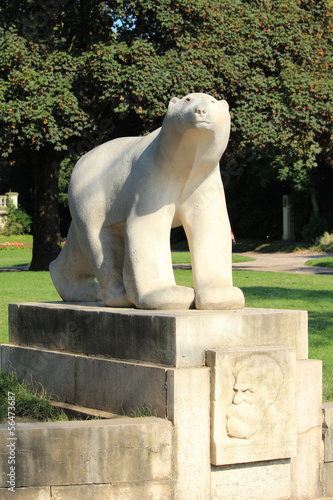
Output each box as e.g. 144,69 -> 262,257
291,359 -> 322,498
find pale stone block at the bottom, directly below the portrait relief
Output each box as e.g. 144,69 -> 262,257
211,459 -> 290,500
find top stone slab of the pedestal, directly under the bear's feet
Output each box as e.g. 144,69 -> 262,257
9,302 -> 308,367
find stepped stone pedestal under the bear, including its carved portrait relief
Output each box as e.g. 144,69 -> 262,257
1,303 -> 321,500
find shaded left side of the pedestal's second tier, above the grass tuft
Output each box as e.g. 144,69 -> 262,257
0,345 -> 167,418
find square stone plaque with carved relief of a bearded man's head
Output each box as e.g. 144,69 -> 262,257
207,346 -> 297,465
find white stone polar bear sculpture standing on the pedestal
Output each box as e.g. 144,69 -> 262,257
50,93 -> 244,309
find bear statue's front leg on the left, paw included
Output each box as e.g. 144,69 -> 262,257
124,205 -> 194,309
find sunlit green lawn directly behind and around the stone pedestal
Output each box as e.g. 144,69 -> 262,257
0,266 -> 333,401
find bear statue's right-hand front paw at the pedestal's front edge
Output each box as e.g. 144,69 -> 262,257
195,285 -> 245,309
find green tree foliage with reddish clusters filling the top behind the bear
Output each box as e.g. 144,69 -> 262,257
0,0 -> 333,267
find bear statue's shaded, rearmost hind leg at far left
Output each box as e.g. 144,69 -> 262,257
50,223 -> 103,302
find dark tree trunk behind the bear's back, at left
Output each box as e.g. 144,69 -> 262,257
30,150 -> 61,271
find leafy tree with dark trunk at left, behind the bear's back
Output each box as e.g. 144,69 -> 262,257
0,0 -> 118,270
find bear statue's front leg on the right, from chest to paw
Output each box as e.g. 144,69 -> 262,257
179,165 -> 245,309
